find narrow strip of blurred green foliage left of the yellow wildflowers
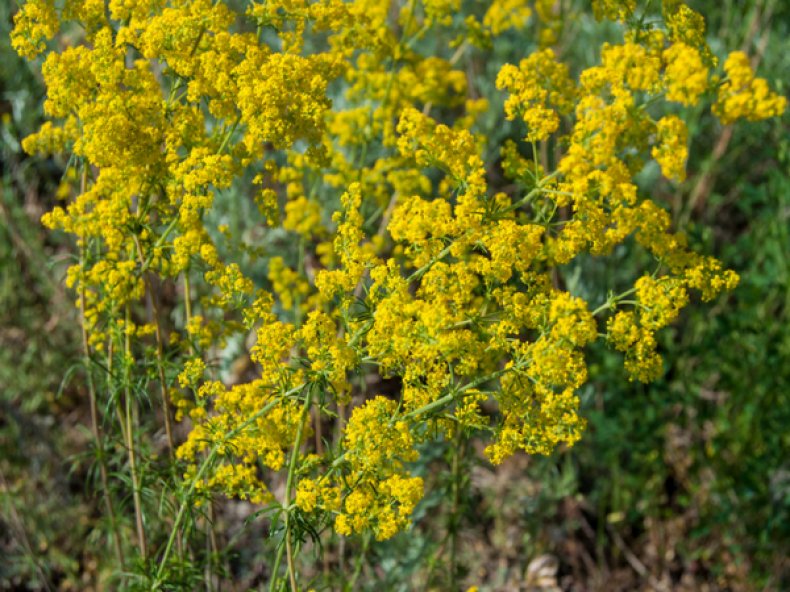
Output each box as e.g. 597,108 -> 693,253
0,2 -> 91,590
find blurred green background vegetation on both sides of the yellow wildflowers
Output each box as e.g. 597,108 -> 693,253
0,0 -> 790,591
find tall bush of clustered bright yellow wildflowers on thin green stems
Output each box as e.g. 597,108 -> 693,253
11,0 -> 786,590
